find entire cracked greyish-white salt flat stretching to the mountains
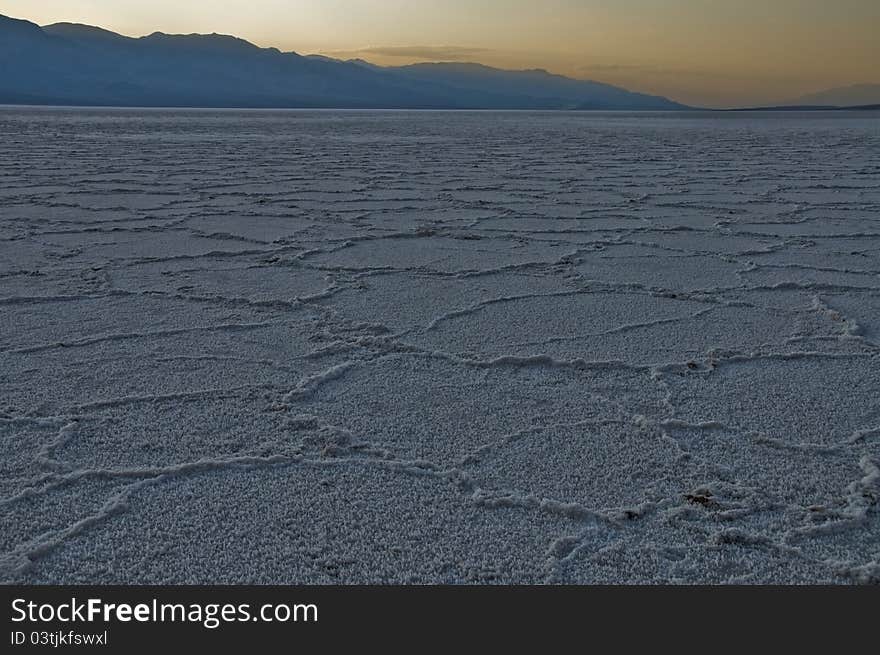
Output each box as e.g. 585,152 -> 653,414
0,108 -> 880,583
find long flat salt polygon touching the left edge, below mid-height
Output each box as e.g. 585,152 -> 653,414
0,321 -> 333,415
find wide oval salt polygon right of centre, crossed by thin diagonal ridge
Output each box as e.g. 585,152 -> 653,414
414,290 -> 843,366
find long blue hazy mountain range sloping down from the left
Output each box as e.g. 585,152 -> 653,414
0,16 -> 685,110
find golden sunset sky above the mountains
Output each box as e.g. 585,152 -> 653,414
0,0 -> 880,106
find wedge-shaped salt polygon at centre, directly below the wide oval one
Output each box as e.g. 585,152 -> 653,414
287,355 -> 663,462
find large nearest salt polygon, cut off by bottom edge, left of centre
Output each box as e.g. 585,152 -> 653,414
12,461 -> 571,583
